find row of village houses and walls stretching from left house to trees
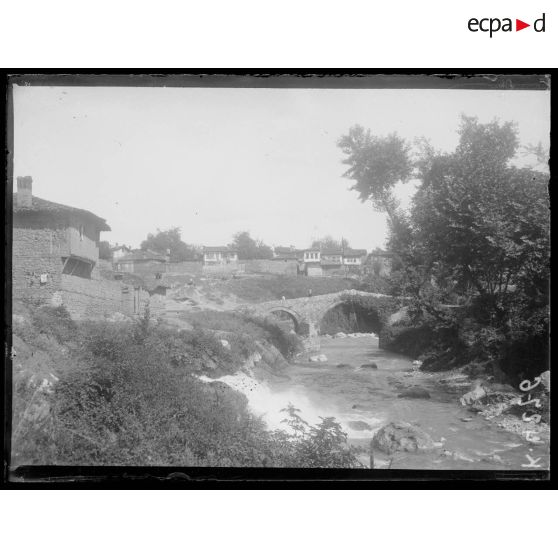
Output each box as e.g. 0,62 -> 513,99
12,176 -> 391,319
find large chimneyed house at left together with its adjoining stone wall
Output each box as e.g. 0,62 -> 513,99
12,176 -> 166,319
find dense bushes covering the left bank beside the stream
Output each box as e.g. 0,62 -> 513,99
12,306 -> 364,467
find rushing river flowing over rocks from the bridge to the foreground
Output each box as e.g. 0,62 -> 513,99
202,337 -> 552,470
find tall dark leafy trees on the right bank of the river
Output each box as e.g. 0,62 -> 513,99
339,116 -> 549,382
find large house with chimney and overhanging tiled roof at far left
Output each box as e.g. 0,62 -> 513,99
12,176 -> 110,300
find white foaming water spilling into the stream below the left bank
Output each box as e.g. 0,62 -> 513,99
198,372 -> 382,438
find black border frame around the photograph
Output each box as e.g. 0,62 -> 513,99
0,69 -> 555,489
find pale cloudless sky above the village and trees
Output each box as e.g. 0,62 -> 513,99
14,86 -> 550,250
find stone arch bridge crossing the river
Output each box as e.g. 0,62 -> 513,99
242,289 -> 403,337
